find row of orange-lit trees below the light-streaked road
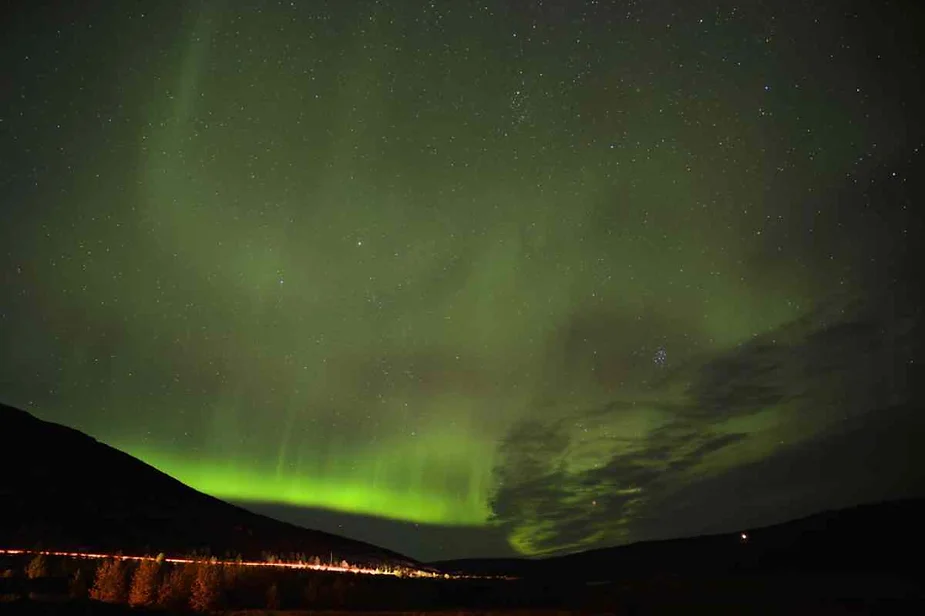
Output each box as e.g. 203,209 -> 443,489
0,554 -> 550,613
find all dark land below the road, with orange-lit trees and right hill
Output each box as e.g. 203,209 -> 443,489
0,500 -> 925,616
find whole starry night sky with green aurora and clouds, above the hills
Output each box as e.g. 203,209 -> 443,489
0,0 -> 925,560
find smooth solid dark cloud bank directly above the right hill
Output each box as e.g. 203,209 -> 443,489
633,405 -> 925,539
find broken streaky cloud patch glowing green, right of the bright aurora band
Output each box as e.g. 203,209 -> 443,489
491,403 -> 745,553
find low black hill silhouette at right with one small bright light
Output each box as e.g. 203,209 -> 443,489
433,499 -> 925,582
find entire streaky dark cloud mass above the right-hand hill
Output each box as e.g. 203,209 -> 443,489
491,282 -> 925,553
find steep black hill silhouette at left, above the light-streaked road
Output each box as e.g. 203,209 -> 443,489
0,404 -> 416,565
